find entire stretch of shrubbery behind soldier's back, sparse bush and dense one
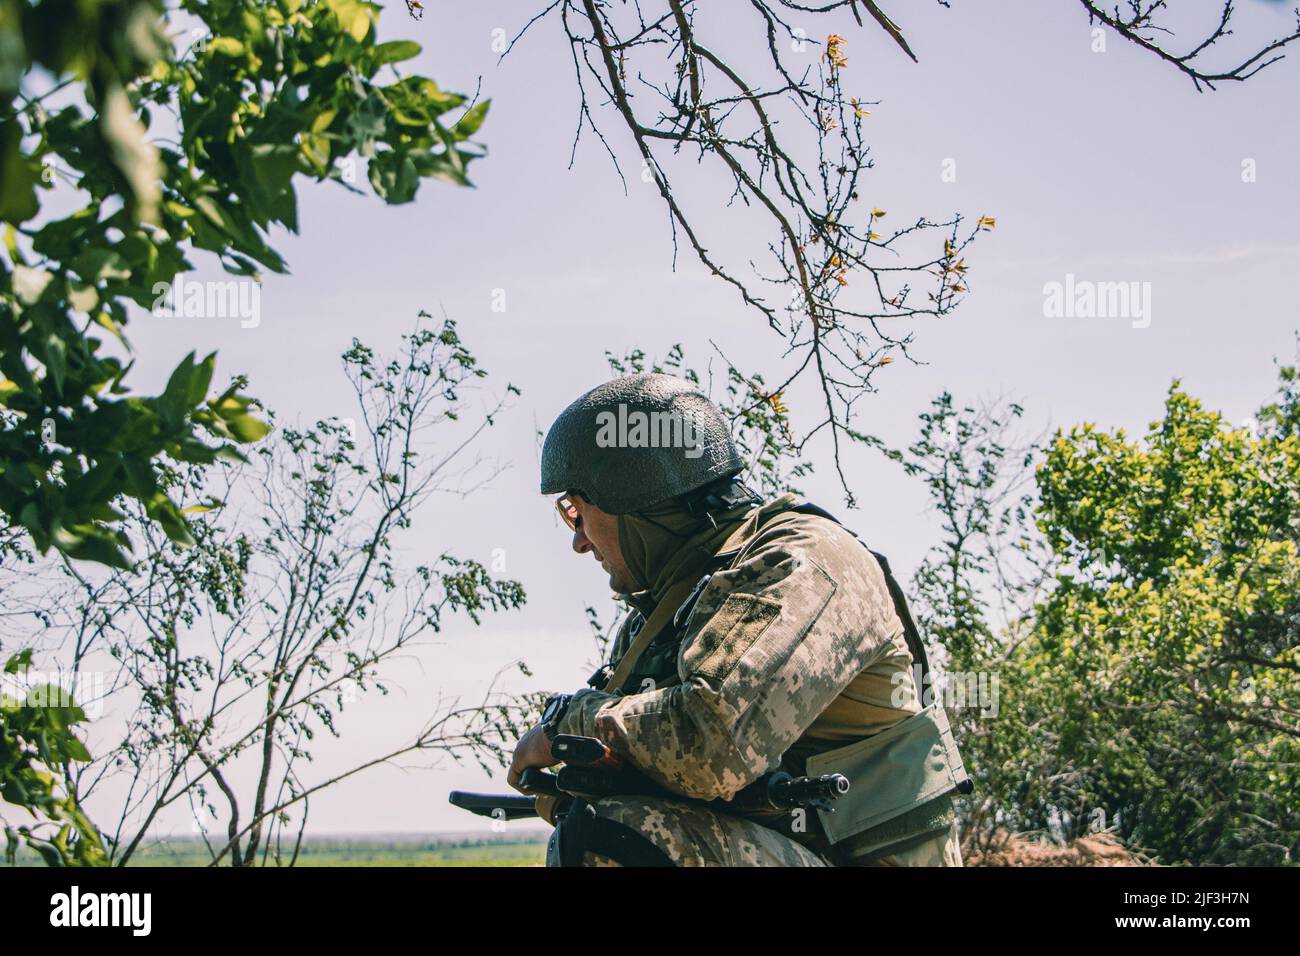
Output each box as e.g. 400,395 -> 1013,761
905,368 -> 1300,865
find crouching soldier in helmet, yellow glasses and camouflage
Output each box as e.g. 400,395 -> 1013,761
508,375 -> 969,866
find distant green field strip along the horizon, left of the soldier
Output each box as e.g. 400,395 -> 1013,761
6,836 -> 546,866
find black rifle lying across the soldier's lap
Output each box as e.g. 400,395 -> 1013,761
449,734 -> 849,819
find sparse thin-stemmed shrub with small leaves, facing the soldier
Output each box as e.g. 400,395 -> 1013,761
8,314 -> 536,866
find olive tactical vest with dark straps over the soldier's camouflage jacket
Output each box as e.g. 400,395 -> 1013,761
589,502 -> 972,865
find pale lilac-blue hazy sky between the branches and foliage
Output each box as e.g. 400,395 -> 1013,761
73,0 -> 1300,832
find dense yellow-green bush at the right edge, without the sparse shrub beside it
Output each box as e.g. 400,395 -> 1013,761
1026,384 -> 1300,865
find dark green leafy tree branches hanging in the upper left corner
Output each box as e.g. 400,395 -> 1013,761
0,0 -> 488,568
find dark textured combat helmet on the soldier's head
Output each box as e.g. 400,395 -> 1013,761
542,372 -> 745,515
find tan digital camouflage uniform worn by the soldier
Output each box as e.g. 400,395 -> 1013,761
551,494 -> 961,866
